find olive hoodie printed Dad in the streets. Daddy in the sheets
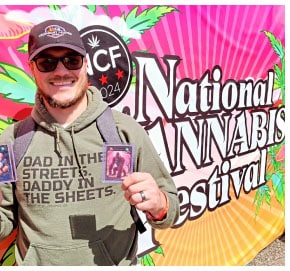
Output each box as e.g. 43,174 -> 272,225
0,87 -> 179,266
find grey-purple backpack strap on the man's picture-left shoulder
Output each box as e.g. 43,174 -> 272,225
13,116 -> 36,167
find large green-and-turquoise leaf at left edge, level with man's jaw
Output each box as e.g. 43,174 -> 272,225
0,62 -> 36,105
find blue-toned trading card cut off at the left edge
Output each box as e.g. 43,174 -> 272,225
0,143 -> 17,183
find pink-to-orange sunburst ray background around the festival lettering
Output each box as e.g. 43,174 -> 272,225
132,5 -> 285,266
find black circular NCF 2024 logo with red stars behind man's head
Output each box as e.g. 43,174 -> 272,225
80,25 -> 132,106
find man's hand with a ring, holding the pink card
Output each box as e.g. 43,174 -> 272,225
121,172 -> 167,217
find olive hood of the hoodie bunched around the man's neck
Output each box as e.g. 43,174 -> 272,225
31,87 -> 107,133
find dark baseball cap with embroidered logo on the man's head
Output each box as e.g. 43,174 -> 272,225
28,20 -> 86,61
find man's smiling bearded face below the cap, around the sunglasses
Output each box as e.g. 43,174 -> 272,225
29,47 -> 88,109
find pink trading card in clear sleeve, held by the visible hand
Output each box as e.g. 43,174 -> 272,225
102,144 -> 134,183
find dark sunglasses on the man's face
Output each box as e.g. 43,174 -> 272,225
32,55 -> 84,72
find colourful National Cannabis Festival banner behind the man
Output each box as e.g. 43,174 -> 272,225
0,5 -> 285,266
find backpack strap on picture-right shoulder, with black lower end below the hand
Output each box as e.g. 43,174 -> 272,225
96,106 -> 146,233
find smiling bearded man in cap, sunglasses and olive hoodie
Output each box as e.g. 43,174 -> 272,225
0,20 -> 179,265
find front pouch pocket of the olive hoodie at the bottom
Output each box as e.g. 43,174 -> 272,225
22,240 -> 115,266
